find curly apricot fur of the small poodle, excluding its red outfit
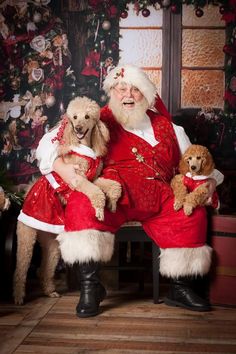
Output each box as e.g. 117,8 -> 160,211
171,144 -> 215,215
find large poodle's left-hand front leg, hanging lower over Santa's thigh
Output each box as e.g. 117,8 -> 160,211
76,176 -> 106,221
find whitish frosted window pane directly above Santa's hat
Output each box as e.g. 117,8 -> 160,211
120,29 -> 162,67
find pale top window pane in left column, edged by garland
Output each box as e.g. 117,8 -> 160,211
120,4 -> 162,27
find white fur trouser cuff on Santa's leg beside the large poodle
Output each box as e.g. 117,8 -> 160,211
56,230 -> 115,265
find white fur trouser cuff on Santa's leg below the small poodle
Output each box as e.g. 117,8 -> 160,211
160,246 -> 212,278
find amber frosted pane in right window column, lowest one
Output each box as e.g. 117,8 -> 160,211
181,70 -> 224,108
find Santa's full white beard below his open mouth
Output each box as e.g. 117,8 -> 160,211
108,93 -> 149,129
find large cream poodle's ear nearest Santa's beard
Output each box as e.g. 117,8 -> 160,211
92,120 -> 110,156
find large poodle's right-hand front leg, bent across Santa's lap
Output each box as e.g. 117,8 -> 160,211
94,177 -> 122,213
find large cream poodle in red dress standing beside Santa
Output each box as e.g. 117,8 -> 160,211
13,97 -> 121,304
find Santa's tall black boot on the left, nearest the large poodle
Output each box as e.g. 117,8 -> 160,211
76,262 -> 106,317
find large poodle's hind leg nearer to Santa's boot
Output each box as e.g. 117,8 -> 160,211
38,231 -> 60,297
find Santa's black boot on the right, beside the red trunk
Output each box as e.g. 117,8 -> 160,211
164,277 -> 211,311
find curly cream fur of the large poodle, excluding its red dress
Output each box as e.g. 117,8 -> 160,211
13,97 -> 121,304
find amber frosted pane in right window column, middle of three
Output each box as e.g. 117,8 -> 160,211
182,29 -> 225,67
